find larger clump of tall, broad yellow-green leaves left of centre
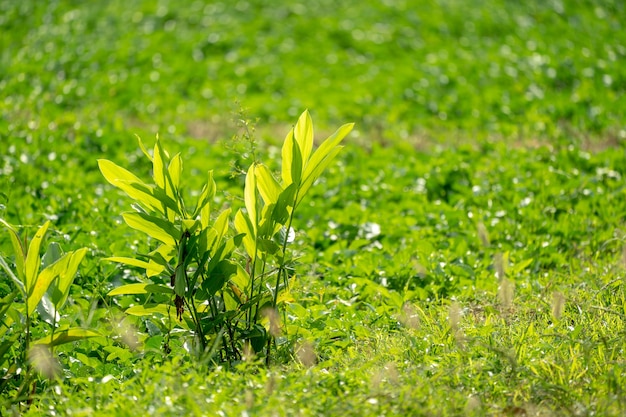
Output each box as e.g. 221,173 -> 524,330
98,111 -> 353,363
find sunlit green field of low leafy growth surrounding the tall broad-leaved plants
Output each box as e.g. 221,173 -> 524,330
0,0 -> 626,416
